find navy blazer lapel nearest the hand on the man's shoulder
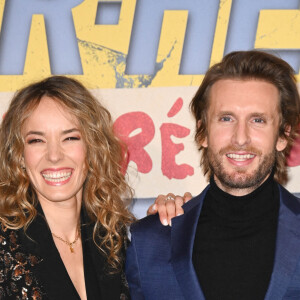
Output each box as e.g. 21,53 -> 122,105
171,187 -> 208,300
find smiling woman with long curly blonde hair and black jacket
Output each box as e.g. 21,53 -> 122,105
0,76 -> 134,300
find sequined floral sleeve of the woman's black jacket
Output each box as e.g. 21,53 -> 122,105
0,223 -> 44,300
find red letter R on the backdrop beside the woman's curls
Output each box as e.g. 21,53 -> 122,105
114,112 -> 155,173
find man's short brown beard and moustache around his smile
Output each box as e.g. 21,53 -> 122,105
207,147 -> 276,189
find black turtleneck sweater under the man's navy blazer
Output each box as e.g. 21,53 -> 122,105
193,175 -> 279,300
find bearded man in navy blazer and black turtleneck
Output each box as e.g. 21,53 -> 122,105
126,51 -> 300,300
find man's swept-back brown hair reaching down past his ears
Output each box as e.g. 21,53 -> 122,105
191,50 -> 300,184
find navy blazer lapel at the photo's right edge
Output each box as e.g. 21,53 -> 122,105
265,187 -> 300,300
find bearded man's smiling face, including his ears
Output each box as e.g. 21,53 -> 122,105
202,79 -> 286,195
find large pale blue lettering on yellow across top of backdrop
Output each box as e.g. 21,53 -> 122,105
0,0 -> 300,74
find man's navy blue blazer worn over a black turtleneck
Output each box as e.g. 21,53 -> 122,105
126,185 -> 300,300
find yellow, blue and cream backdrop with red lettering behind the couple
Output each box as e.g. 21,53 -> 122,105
0,0 -> 300,217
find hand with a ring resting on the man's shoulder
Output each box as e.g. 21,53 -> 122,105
147,192 -> 192,226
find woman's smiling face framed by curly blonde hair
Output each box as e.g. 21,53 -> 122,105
22,96 -> 87,206
